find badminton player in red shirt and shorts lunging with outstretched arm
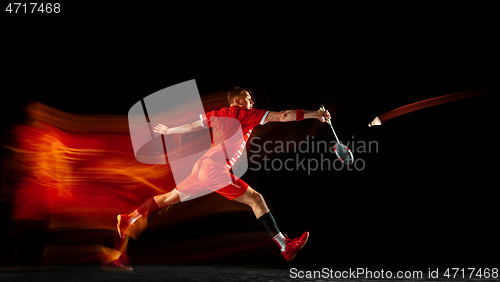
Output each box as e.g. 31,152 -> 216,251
117,87 -> 330,261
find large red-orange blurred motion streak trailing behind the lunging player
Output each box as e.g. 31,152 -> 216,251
2,103 -> 174,229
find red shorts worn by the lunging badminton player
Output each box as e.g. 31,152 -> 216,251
176,157 -> 249,200
